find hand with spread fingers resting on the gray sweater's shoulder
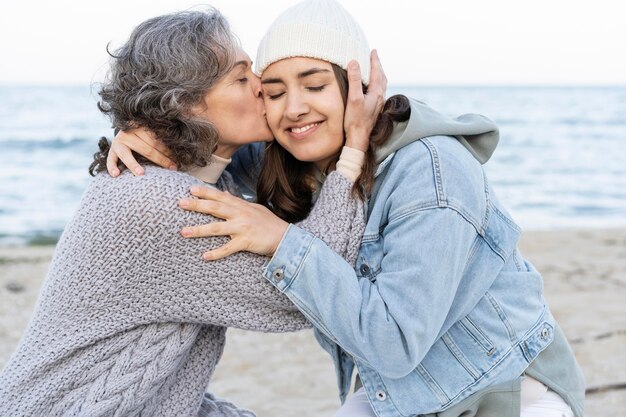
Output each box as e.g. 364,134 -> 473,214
179,187 -> 289,261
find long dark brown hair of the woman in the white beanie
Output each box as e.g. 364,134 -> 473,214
257,64 -> 411,223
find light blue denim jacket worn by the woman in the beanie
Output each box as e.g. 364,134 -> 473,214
265,136 -> 572,417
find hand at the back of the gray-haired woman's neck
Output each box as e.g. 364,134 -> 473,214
107,128 -> 176,177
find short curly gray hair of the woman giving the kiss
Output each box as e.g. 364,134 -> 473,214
90,8 -> 238,173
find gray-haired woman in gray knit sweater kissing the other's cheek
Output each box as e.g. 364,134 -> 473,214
0,10 -> 384,417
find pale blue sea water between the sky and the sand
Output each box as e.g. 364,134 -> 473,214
0,86 -> 626,245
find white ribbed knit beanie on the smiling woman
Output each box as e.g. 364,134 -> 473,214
256,0 -> 370,85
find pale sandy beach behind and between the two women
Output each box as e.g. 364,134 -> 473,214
0,229 -> 626,417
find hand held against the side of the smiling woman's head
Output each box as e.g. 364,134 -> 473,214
344,50 -> 387,152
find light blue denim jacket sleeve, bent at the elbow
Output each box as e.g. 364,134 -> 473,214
265,199 -> 476,378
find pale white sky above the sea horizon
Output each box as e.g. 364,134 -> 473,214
0,0 -> 626,85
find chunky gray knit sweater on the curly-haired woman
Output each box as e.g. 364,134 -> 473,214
0,167 -> 364,417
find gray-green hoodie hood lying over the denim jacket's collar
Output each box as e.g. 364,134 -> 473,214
376,98 -> 500,164
